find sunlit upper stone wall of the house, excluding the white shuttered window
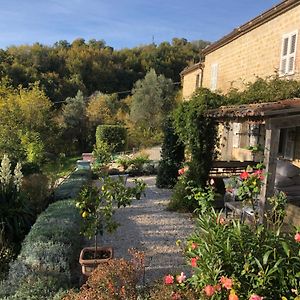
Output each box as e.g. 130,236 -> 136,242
182,0 -> 300,99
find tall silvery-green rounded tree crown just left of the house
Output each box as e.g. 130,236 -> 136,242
130,69 -> 174,131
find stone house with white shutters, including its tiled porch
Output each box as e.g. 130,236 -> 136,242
181,0 -> 300,220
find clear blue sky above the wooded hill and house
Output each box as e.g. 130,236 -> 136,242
0,0 -> 280,49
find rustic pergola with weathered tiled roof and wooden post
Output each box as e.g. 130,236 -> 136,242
208,98 -> 300,221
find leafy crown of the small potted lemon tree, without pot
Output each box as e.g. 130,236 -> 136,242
76,176 -> 146,238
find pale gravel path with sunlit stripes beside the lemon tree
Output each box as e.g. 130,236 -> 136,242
95,176 -> 194,283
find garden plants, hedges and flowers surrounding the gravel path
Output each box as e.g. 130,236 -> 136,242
0,76 -> 300,300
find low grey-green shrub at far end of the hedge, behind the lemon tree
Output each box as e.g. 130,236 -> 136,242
54,170 -> 91,200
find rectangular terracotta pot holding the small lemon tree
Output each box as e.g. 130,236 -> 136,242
79,247 -> 114,277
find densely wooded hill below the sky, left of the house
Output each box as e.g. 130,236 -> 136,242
0,38 -> 208,102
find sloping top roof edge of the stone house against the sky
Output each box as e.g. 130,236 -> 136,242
202,0 -> 300,55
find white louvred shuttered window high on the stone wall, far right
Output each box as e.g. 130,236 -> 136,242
279,31 -> 298,75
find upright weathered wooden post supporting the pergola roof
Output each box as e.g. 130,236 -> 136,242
259,121 -> 280,223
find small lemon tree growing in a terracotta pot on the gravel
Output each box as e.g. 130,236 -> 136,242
76,176 -> 146,276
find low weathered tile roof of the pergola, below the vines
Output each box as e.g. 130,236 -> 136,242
207,98 -> 300,119
